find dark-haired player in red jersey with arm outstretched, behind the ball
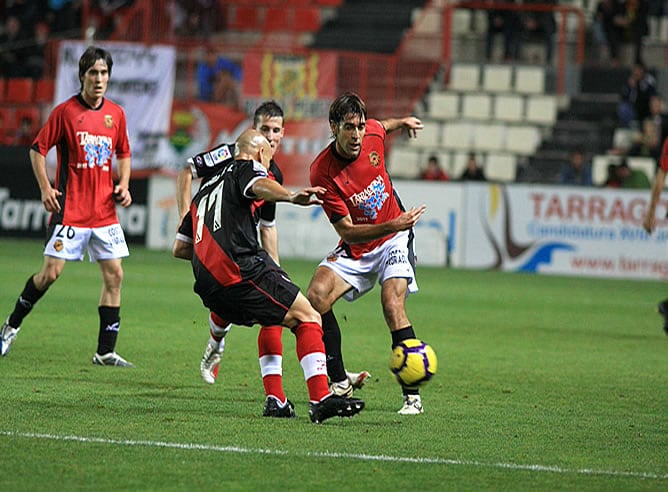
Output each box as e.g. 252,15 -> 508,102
307,93 -> 425,415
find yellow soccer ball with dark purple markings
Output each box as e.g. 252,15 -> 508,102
390,338 -> 438,387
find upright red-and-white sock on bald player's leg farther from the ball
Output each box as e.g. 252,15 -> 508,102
257,326 -> 287,403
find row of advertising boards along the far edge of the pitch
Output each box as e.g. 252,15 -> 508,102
0,160 -> 668,280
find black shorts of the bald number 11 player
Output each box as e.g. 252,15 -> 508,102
195,264 -> 299,326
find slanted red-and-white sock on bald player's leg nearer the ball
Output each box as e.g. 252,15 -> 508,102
295,323 -> 329,403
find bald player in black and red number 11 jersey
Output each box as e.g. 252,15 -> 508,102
173,129 -> 364,423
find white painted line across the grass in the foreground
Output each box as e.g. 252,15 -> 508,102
0,431 -> 668,480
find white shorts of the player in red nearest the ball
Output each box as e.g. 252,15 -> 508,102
319,231 -> 418,302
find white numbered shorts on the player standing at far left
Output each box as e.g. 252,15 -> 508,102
44,224 -> 130,262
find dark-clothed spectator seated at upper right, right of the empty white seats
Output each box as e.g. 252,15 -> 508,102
618,62 -> 657,128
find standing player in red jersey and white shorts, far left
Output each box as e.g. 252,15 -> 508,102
0,46 -> 132,367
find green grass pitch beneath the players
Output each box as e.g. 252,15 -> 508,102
0,239 -> 668,491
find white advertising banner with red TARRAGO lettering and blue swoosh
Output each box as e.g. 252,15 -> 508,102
457,184 -> 668,279
